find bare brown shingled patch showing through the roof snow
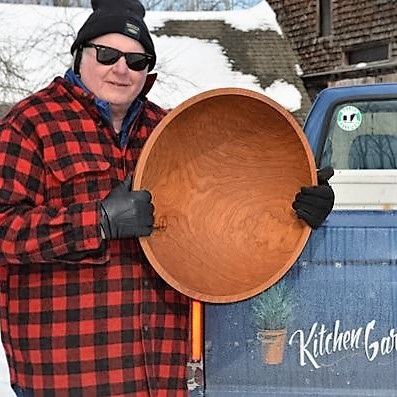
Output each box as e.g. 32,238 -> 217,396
152,13 -> 310,123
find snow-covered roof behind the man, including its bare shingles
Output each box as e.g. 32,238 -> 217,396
0,1 -> 307,118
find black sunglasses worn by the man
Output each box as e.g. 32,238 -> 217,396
83,43 -> 153,71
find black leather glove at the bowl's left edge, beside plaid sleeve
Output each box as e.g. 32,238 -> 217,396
101,176 -> 154,240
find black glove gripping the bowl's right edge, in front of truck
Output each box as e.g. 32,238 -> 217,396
292,166 -> 335,229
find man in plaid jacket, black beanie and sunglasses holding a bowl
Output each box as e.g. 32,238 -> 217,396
0,0 -> 333,397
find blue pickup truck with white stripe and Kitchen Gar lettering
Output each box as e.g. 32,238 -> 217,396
191,84 -> 397,397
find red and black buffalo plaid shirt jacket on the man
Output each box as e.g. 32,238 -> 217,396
0,78 -> 189,397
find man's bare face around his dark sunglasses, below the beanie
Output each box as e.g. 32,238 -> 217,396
80,33 -> 148,109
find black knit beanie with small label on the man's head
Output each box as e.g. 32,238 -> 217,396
70,0 -> 156,71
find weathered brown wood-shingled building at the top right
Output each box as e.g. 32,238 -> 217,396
267,0 -> 397,98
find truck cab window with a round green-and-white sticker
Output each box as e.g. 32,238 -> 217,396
321,99 -> 397,170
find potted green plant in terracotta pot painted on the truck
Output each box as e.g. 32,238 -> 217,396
252,281 -> 295,365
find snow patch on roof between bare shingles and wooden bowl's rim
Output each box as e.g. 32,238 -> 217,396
149,37 -> 301,112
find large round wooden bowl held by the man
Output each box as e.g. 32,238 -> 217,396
133,88 -> 317,303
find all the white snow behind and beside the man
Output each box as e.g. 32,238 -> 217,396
0,0 -> 302,397
